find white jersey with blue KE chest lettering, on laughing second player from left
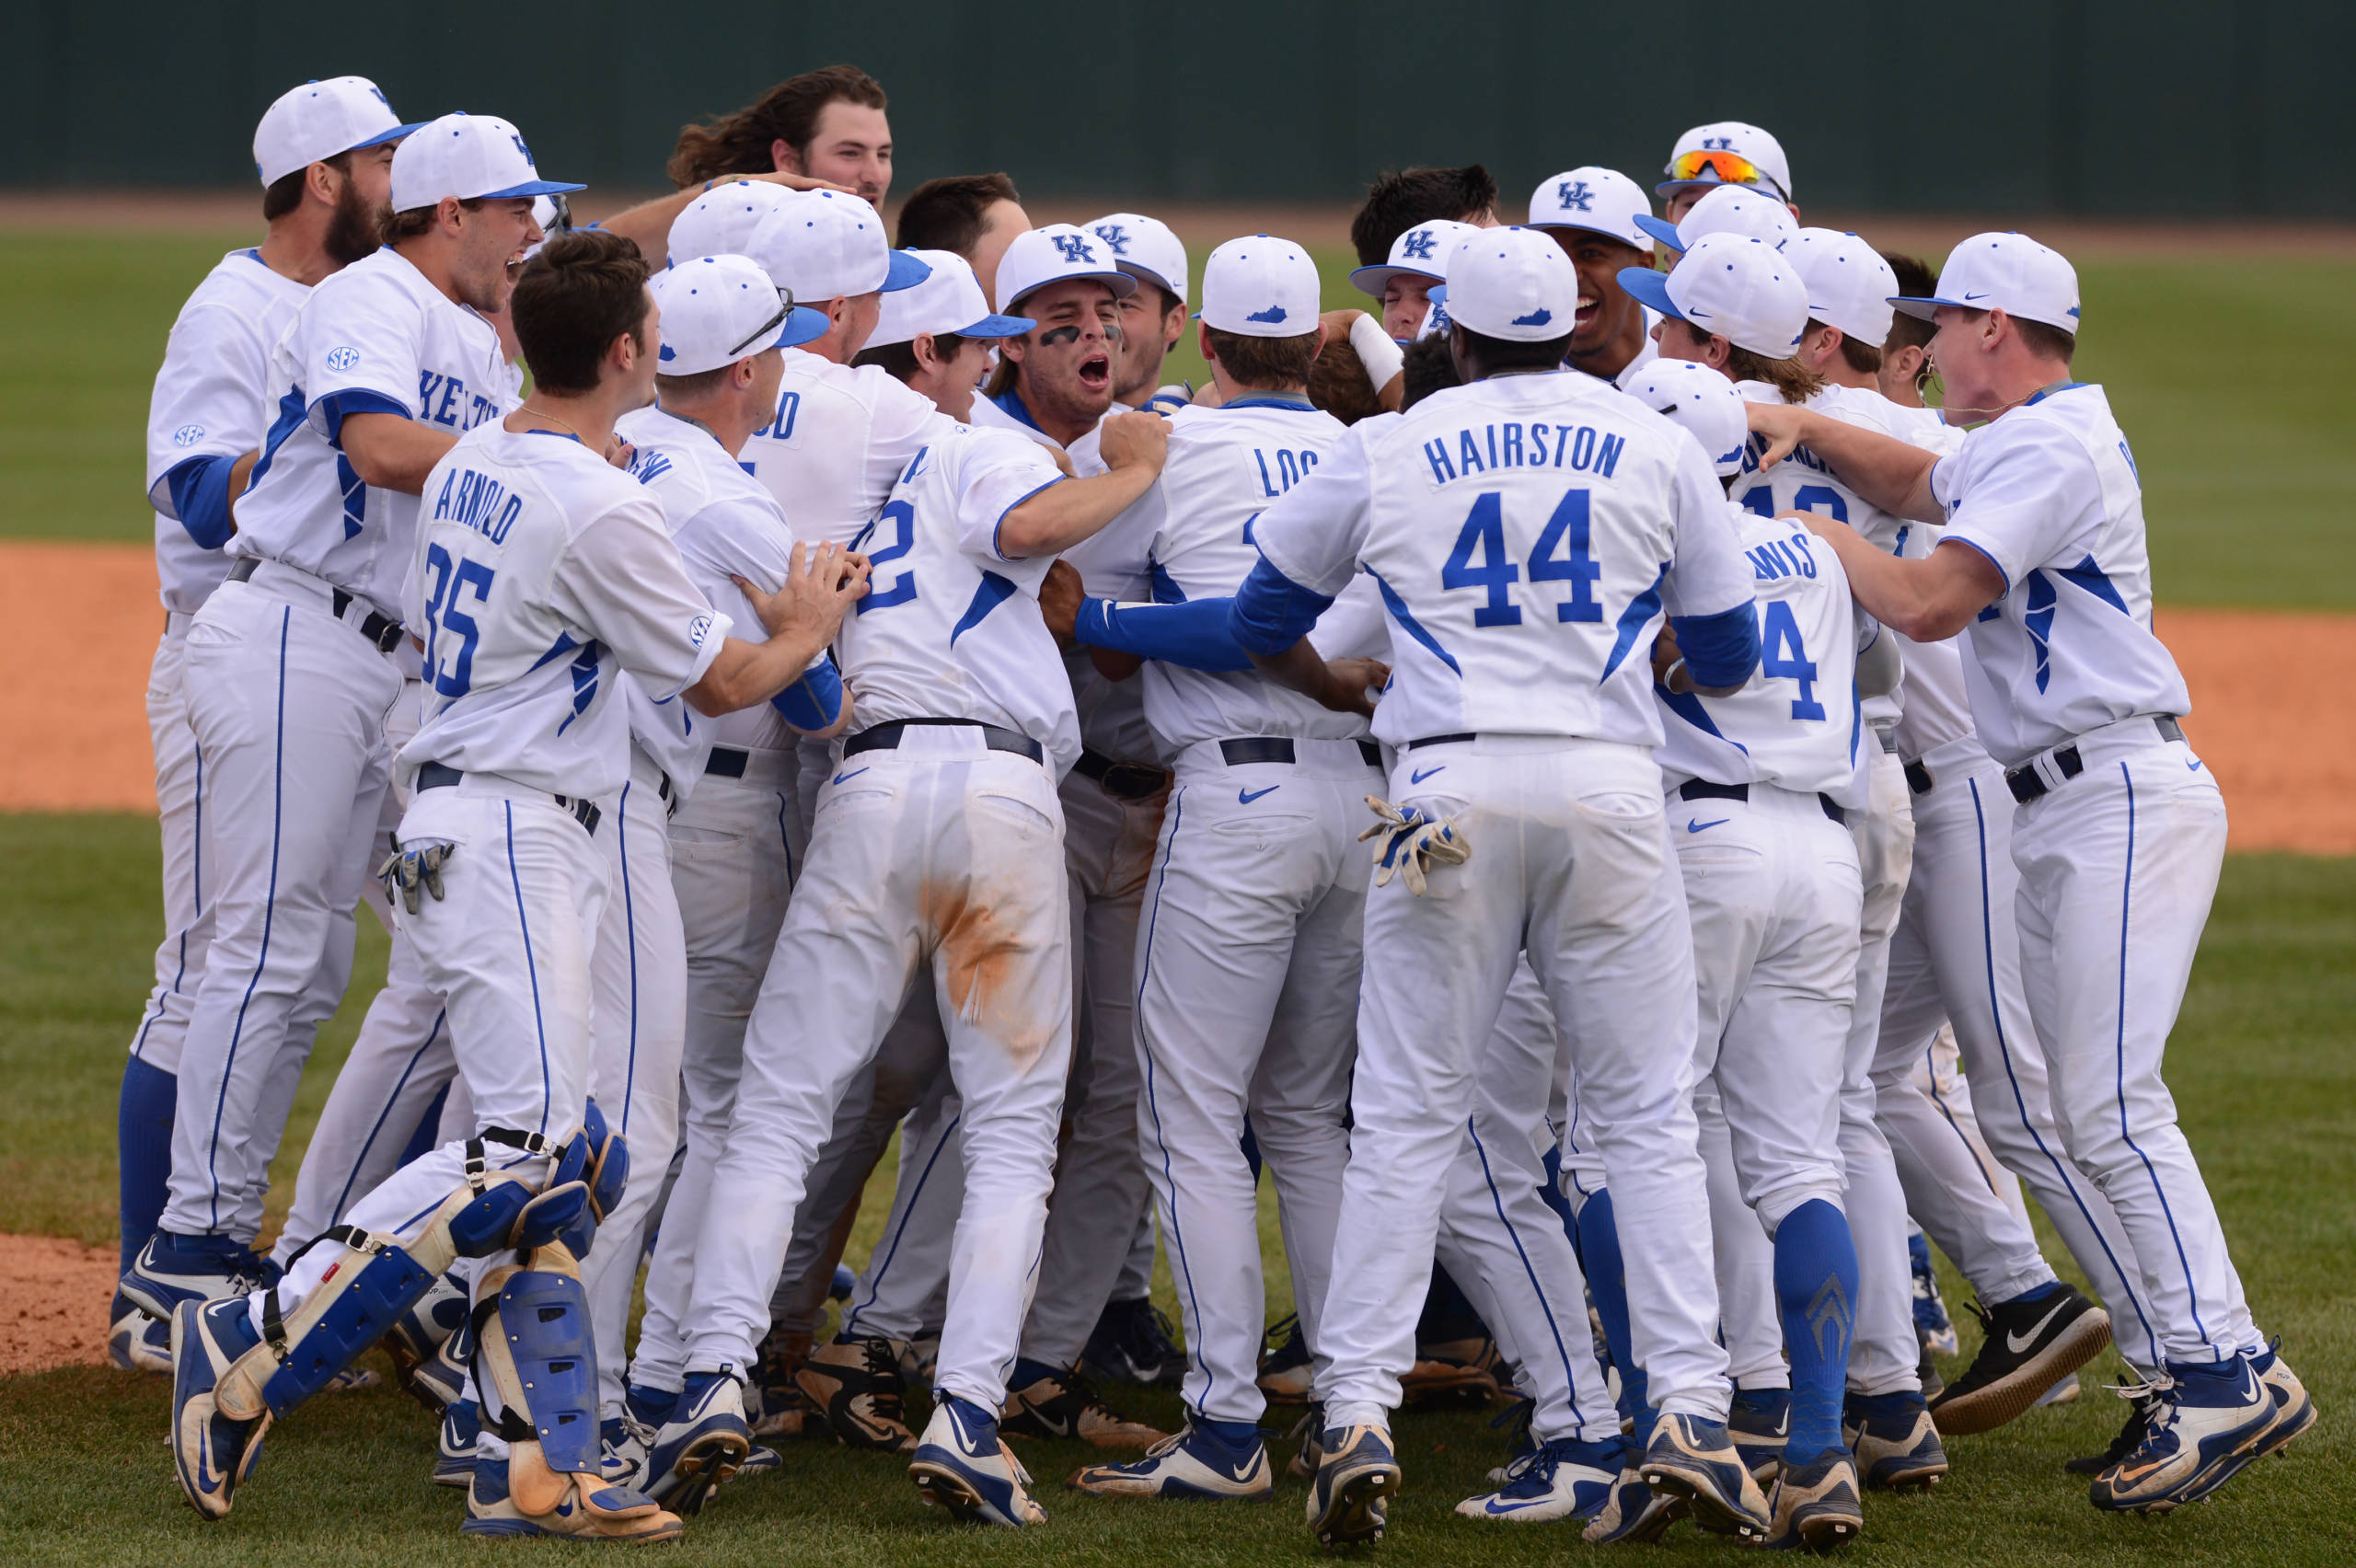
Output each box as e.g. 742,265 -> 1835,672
228,245 -> 514,617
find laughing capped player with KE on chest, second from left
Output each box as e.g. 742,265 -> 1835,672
122,115 -> 577,1311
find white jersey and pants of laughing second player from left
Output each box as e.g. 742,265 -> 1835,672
163,248 -> 512,1234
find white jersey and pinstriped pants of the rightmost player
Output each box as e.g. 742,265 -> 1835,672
1932,384 -> 2259,1363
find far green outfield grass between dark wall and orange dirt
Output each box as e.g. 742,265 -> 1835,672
0,231 -> 2356,610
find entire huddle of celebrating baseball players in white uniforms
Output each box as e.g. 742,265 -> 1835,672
109,66 -> 2316,1551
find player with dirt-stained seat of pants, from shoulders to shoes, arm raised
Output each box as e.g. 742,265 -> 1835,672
655,398 -> 1164,1526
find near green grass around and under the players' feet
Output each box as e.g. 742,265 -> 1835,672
0,817 -> 2356,1568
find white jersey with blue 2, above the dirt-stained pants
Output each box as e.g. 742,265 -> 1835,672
834,424 -> 1079,777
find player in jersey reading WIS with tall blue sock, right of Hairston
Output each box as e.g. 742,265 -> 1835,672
1631,360 -> 1897,1551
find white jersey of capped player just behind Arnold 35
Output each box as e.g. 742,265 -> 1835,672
615,408 -> 825,781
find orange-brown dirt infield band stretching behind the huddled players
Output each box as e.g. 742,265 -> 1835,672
0,544 -> 2356,855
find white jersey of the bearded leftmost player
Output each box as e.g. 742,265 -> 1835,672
146,249 -> 311,615
